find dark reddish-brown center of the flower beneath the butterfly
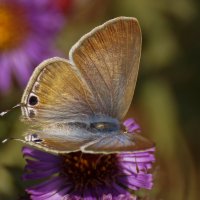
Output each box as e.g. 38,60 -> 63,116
62,152 -> 118,189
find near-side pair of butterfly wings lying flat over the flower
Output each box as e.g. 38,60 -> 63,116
24,124 -> 154,154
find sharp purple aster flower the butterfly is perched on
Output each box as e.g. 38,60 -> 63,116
22,119 -> 155,200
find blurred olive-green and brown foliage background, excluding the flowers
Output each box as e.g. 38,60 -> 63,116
0,0 -> 200,200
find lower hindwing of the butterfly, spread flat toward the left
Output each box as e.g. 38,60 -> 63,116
25,123 -> 101,153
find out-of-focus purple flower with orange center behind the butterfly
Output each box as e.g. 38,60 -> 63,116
0,0 -> 64,92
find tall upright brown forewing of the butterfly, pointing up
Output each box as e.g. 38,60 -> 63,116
70,17 -> 141,120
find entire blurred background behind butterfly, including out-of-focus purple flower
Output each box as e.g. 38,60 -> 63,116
0,0 -> 200,200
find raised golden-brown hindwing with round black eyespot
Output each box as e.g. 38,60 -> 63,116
21,58 -> 96,124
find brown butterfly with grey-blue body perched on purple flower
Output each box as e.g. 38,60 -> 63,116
18,17 -> 153,154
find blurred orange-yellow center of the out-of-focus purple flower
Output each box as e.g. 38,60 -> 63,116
0,4 -> 29,51
